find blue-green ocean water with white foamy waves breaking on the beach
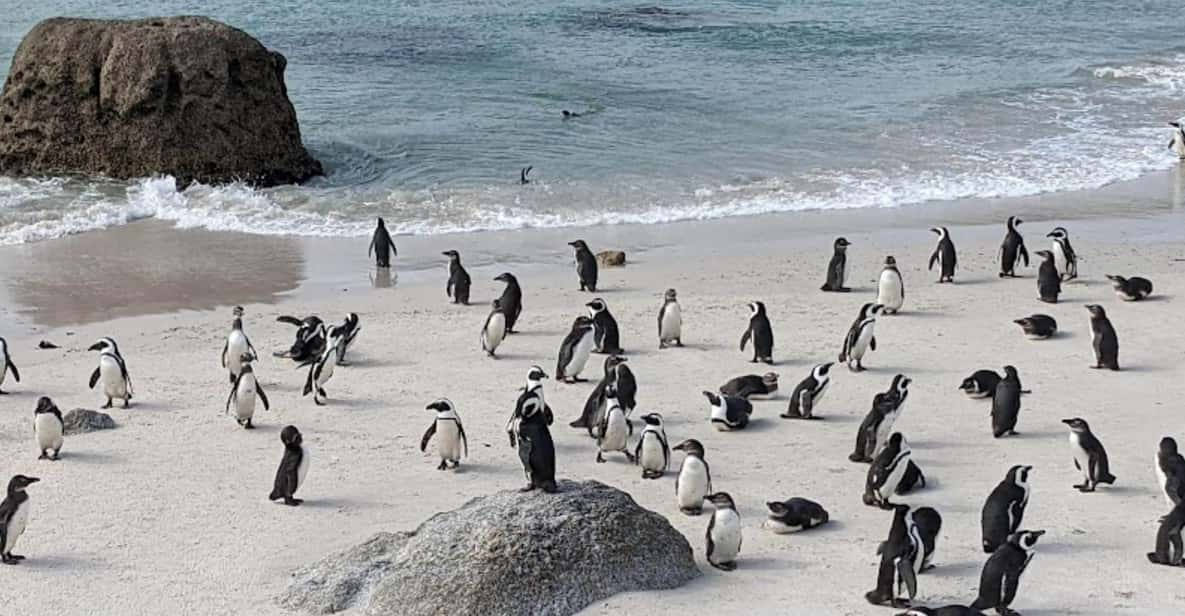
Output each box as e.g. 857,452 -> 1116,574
0,0 -> 1185,244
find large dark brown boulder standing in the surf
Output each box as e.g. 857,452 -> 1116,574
0,17 -> 322,186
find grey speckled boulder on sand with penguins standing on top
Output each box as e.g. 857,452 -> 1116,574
277,481 -> 699,616
